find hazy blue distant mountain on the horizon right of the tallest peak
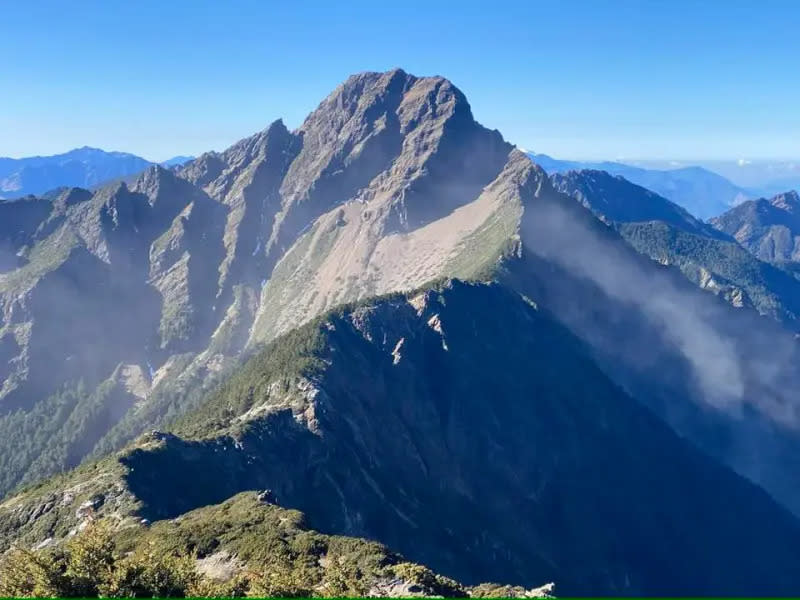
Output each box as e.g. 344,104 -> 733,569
528,153 -> 753,220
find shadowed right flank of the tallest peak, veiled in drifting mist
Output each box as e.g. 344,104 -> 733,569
522,190 -> 800,511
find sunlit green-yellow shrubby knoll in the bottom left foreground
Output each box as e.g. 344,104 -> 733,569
0,493 -> 476,597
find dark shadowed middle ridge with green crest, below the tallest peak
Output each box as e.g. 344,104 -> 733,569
7,282 -> 800,596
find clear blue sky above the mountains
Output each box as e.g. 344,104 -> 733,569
0,0 -> 800,160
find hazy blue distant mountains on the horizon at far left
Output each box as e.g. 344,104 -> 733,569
0,146 -> 192,199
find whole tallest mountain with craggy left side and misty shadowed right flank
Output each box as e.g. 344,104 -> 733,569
0,70 -> 800,585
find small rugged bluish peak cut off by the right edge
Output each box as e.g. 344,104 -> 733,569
710,191 -> 800,263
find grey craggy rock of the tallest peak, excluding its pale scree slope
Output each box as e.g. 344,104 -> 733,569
0,70 -> 511,496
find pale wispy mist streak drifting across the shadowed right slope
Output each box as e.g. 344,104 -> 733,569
524,192 -> 798,426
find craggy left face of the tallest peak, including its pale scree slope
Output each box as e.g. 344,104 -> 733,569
0,70 -> 517,492
